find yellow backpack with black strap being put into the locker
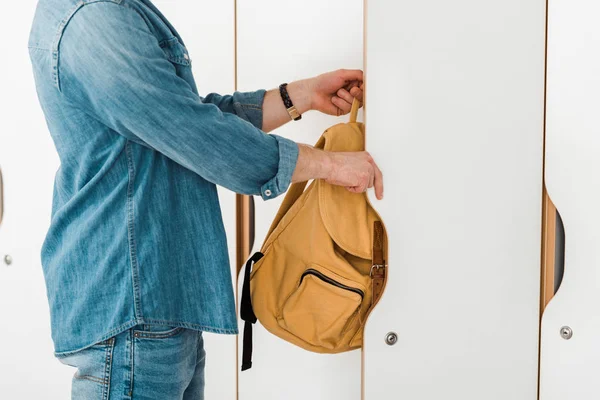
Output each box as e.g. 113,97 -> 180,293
241,101 -> 386,371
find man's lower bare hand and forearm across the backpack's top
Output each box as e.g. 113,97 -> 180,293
292,144 -> 383,200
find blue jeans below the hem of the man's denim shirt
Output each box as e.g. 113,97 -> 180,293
59,324 -> 206,400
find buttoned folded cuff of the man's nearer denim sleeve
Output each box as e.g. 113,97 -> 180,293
260,135 -> 298,200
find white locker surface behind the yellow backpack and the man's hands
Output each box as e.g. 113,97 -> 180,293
237,0 -> 363,400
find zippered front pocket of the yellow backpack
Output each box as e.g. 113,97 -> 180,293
277,264 -> 365,350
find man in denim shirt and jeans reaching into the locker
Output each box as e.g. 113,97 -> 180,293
29,0 -> 383,400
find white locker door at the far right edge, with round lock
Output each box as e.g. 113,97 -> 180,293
540,0 -> 600,400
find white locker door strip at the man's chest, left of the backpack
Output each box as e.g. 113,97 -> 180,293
153,0 -> 236,400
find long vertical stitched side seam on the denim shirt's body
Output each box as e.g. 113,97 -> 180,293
125,140 -> 143,319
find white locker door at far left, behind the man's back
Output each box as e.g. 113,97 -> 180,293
0,0 -> 72,399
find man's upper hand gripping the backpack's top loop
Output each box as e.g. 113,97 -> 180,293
306,69 -> 363,115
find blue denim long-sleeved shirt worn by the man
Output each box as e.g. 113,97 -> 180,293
29,0 -> 298,355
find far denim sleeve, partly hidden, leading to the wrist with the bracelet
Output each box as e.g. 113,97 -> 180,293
202,89 -> 266,129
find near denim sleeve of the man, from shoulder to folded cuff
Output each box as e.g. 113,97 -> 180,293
59,2 -> 298,200
